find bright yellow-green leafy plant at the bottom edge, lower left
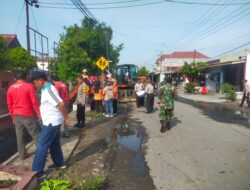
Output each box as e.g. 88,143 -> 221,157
40,179 -> 72,190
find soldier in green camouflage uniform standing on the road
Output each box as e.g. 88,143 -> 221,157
158,78 -> 176,133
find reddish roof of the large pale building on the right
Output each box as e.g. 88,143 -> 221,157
156,51 -> 209,62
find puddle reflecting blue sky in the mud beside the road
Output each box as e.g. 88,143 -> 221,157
113,121 -> 148,176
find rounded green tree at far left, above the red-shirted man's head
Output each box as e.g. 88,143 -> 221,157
6,47 -> 37,71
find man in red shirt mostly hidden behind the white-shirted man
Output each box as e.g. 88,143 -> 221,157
51,75 -> 72,138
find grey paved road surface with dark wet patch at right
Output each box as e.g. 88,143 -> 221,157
132,99 -> 250,190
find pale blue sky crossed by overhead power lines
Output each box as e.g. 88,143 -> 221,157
0,0 -> 250,69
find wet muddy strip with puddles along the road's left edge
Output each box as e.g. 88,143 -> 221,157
109,118 -> 155,190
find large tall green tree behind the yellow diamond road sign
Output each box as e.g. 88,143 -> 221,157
51,18 -> 123,81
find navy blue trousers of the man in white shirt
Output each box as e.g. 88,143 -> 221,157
32,124 -> 64,174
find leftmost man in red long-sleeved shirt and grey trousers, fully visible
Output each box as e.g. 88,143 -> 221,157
7,72 -> 41,159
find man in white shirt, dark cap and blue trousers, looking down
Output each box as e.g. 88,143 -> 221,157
32,72 -> 69,178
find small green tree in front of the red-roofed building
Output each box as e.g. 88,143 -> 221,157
181,62 -> 206,77
